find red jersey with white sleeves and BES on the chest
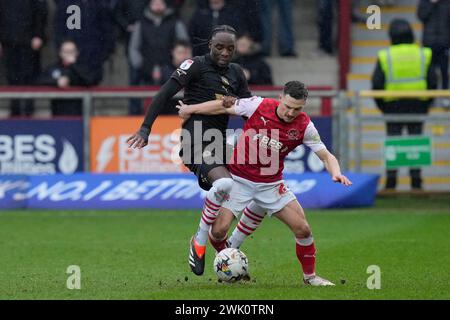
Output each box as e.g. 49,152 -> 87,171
228,97 -> 326,183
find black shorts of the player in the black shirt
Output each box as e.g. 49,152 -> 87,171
180,144 -> 233,191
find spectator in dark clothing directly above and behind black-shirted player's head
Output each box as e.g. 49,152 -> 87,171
189,0 -> 250,56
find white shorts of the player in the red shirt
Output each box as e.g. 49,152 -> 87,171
222,175 -> 297,218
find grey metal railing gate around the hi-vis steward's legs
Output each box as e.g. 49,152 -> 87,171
334,90 -> 450,190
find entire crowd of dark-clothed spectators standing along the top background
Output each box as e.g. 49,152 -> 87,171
0,0 -> 450,116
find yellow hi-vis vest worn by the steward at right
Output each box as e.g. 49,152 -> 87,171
378,43 -> 431,101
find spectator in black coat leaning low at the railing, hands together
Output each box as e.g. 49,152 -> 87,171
37,41 -> 95,116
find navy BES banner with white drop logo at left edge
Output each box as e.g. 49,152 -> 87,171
0,120 -> 83,175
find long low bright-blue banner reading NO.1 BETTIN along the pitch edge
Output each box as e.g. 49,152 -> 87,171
0,173 -> 379,210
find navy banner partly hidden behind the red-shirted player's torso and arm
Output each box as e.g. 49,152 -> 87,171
228,117 -> 332,173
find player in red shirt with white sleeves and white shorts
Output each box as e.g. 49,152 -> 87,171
179,81 -> 352,286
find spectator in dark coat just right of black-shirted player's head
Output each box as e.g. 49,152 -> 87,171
234,34 -> 273,85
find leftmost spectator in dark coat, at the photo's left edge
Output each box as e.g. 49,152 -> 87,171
0,0 -> 47,116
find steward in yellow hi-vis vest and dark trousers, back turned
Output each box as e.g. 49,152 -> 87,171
372,19 -> 437,189
